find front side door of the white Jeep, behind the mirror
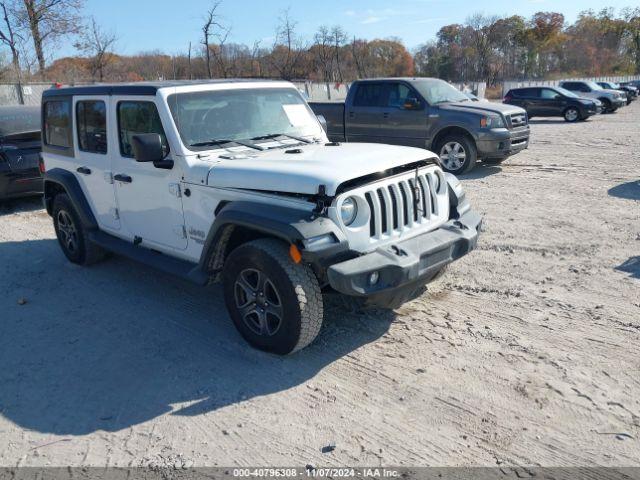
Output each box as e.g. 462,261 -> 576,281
111,97 -> 187,250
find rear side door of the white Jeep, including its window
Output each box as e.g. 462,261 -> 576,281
73,95 -> 120,231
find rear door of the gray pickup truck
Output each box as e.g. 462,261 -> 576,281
344,82 -> 387,143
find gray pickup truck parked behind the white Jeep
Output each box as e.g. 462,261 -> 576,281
309,78 -> 529,175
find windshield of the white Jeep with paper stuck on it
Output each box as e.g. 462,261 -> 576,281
168,88 -> 322,150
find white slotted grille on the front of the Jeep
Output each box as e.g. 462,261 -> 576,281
364,171 -> 445,239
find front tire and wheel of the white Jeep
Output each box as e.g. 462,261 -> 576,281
222,239 -> 323,355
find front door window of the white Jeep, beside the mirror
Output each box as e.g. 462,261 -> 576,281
118,101 -> 169,158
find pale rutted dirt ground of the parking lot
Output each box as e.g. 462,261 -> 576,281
0,101 -> 640,467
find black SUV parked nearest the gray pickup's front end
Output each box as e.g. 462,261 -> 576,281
503,87 -> 601,122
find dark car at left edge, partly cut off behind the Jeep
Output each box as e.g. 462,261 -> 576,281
0,106 -> 42,200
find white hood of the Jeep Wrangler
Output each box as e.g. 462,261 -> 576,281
207,143 -> 437,196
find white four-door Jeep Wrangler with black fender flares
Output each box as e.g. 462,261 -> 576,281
41,80 -> 481,354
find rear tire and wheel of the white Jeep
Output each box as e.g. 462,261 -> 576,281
52,193 -> 107,265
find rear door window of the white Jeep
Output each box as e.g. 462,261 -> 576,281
76,100 -> 107,154
